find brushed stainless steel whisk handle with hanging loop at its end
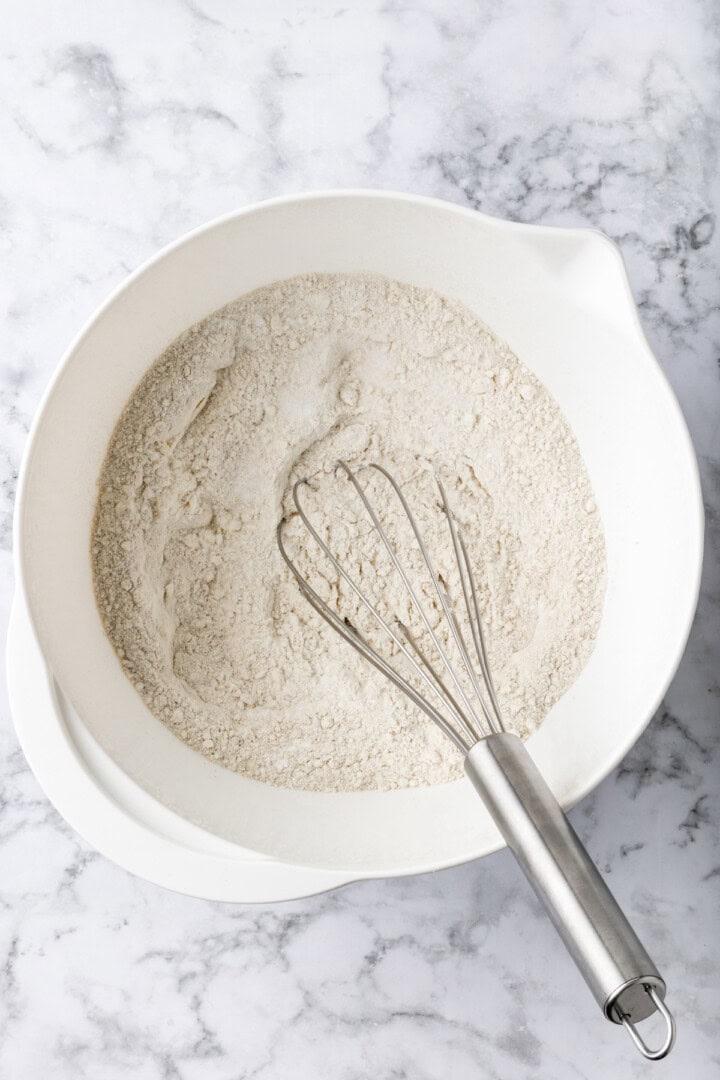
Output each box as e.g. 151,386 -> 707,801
465,732 -> 675,1061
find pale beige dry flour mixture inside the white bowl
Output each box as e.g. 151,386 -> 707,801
92,274 -> 606,791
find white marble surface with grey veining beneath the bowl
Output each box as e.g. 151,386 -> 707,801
0,0 -> 720,1080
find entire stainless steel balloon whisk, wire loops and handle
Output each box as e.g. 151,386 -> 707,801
277,462 -> 675,1061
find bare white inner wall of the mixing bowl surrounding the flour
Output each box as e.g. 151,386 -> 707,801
16,191 -> 703,899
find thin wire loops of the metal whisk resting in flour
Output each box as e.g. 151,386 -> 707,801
277,461 -> 504,753
